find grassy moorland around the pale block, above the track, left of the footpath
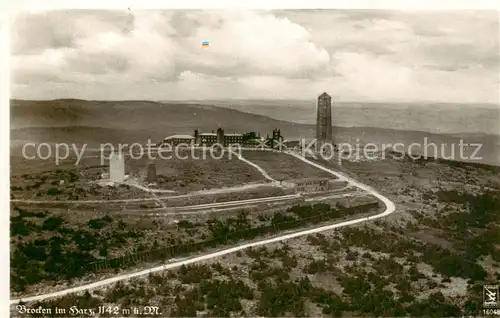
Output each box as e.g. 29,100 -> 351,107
11,151 -> 267,201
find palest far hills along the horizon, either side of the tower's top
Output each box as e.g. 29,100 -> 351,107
169,98 -> 500,136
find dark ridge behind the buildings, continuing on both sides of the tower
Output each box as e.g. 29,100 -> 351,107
10,99 -> 500,165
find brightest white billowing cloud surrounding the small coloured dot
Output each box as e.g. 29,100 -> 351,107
167,11 -> 330,77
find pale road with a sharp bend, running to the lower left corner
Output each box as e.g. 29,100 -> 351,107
10,152 -> 396,304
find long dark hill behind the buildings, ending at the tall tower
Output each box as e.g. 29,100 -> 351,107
10,99 -> 314,137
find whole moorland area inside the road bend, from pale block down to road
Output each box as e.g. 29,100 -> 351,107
11,145 -> 381,295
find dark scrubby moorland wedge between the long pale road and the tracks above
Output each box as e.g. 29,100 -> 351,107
11,194 -> 380,294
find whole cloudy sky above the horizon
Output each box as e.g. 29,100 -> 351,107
11,10 -> 499,103
